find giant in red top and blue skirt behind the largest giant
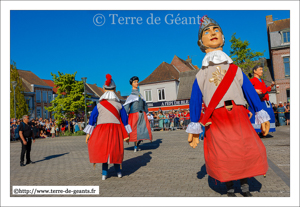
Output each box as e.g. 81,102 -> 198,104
249,65 -> 276,137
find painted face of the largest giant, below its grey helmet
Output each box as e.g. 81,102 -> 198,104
202,26 -> 223,48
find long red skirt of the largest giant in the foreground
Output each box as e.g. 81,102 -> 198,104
204,103 -> 268,182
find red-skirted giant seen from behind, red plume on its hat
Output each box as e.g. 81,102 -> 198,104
83,74 -> 132,180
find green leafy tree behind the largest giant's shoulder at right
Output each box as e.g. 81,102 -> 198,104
229,33 -> 268,78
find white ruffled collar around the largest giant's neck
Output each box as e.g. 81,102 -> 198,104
202,50 -> 233,66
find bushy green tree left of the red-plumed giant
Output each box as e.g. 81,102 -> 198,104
46,72 -> 92,131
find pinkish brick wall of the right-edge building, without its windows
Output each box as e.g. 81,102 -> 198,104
271,48 -> 292,103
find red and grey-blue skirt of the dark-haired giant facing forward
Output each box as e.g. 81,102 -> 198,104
128,112 -> 152,142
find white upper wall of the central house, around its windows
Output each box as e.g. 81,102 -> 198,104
139,81 -> 178,102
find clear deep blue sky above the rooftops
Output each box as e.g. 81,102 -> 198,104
10,10 -> 290,95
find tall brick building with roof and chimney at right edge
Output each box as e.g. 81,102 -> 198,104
266,15 -> 290,103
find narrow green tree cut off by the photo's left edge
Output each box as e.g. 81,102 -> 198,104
10,62 -> 29,119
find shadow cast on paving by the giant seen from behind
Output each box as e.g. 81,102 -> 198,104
108,152 -> 152,176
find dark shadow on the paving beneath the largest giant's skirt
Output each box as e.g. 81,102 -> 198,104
197,164 -> 262,195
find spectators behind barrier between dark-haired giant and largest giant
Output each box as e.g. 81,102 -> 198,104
147,108 -> 190,131
